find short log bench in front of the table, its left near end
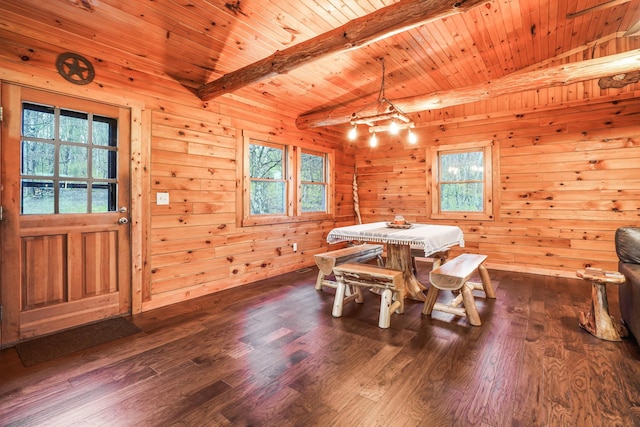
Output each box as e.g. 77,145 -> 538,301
331,263 -> 405,329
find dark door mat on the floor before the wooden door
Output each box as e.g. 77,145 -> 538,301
16,317 -> 142,366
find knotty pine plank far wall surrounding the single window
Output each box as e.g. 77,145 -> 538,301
356,39 -> 640,277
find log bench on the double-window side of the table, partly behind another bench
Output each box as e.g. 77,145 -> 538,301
314,243 -> 382,291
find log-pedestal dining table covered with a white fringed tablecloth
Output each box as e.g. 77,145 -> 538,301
327,221 -> 464,301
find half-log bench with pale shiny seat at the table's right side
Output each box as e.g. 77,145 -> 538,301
422,254 -> 496,326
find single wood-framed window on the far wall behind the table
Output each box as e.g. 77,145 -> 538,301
431,141 -> 498,220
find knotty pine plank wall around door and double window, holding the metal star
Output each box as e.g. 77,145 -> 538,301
0,10 -> 354,312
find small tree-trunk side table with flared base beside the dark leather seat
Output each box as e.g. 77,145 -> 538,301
576,268 -> 627,341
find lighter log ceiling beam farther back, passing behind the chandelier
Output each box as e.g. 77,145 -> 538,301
296,49 -> 640,129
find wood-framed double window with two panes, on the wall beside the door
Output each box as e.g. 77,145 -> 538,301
241,131 -> 334,226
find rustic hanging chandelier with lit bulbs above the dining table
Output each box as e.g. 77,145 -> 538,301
347,58 -> 418,147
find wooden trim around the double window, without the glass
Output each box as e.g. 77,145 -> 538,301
236,130 -> 335,227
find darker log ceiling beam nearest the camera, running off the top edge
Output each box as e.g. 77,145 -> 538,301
197,0 -> 486,101
